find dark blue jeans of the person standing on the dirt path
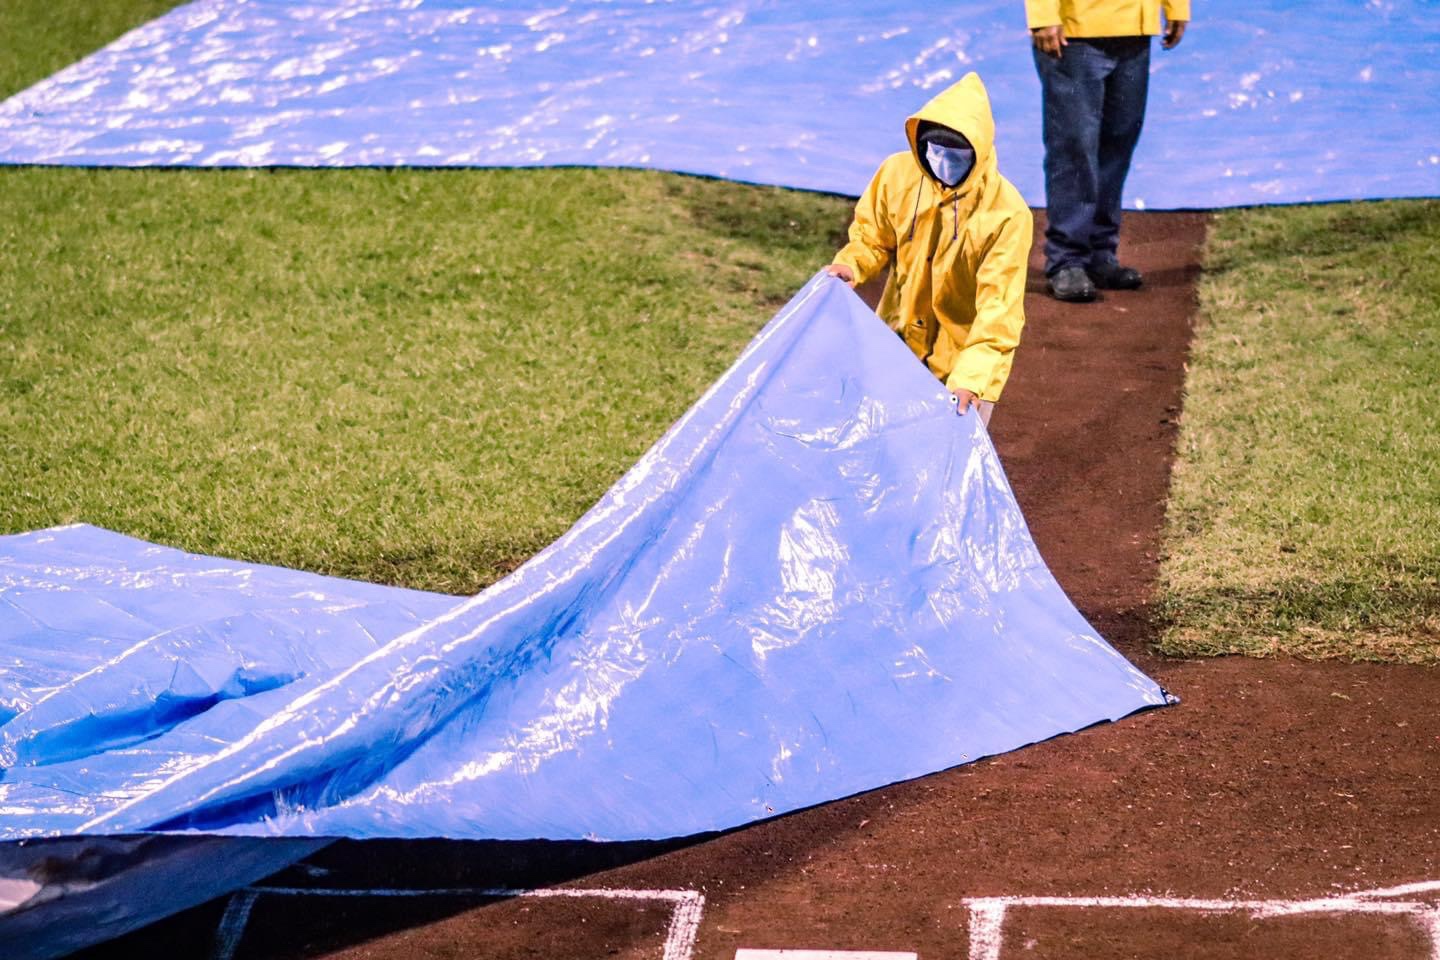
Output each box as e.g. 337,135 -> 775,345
1034,36 -> 1151,276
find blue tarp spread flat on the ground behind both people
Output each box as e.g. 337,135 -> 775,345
0,0 -> 1440,209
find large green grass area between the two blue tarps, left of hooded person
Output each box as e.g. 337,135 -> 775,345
0,170 -> 847,593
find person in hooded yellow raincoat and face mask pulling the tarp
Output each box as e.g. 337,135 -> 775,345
827,73 -> 1032,423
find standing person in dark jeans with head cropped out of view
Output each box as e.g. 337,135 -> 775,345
1025,0 -> 1189,302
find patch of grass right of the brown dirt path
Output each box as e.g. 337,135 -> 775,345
1162,200 -> 1440,664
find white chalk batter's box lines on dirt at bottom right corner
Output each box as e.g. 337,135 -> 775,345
962,881 -> 1440,960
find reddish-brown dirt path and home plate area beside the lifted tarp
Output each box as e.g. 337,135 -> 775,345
73,213 -> 1440,960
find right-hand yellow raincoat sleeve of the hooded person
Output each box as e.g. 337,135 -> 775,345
945,207 -> 1034,400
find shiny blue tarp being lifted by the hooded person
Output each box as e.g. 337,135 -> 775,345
0,276 -> 1165,839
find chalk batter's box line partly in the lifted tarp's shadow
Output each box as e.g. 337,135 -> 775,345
212,887 -> 706,960
